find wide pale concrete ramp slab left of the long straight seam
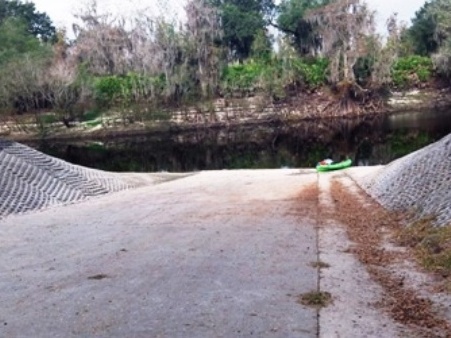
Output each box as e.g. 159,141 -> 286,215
0,170 -> 318,337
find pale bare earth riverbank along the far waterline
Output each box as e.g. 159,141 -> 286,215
0,88 -> 451,141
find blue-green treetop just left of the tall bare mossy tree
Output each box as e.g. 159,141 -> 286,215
273,0 -> 331,55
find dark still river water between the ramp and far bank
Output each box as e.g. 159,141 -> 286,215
30,110 -> 451,172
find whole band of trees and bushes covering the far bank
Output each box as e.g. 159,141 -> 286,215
0,0 -> 451,127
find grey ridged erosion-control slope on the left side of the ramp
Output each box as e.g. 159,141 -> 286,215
0,140 -> 148,218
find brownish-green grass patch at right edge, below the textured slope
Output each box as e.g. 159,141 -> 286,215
398,217 -> 451,278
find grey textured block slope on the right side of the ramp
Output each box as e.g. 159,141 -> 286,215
362,134 -> 451,226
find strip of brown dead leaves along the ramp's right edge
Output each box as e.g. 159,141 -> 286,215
331,180 -> 451,337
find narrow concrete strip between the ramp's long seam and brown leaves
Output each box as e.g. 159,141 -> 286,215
318,173 -> 406,338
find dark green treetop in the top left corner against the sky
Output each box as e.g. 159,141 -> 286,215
0,0 -> 56,42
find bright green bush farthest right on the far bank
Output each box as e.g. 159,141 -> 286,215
392,55 -> 434,87
